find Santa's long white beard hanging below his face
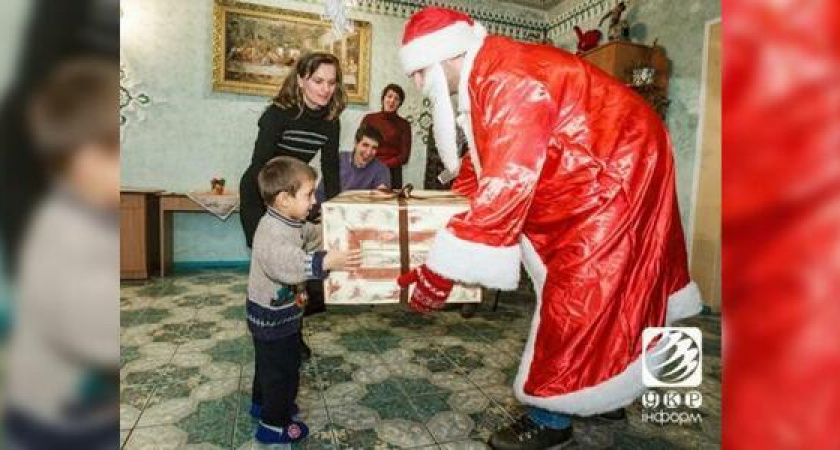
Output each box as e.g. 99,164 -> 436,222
423,63 -> 461,176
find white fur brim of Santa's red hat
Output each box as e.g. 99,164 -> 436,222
399,21 -> 484,76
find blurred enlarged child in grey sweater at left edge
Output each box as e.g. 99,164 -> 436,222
4,58 -> 120,449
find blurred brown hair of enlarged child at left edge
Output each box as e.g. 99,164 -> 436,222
27,57 -> 120,172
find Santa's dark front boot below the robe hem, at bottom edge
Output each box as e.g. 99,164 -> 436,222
489,414 -> 572,450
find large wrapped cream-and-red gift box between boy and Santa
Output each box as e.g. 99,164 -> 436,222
322,189 -> 481,305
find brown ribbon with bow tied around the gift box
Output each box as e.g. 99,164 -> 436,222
345,183 -> 463,303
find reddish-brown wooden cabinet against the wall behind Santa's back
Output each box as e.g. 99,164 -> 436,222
583,41 -> 669,119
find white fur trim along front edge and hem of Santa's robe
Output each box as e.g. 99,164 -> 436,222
513,236 -> 703,416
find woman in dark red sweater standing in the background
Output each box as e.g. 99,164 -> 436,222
362,83 -> 411,189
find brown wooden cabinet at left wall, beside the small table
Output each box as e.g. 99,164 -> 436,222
120,189 -> 161,280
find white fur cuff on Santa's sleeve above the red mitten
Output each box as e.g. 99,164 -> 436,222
426,228 -> 521,291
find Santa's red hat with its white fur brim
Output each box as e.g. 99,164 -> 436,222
400,6 -> 486,75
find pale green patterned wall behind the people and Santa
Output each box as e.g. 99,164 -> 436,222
121,0 -> 720,262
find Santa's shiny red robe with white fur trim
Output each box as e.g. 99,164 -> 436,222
427,36 -> 701,415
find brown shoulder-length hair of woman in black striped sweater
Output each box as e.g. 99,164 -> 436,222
273,53 -> 347,120
